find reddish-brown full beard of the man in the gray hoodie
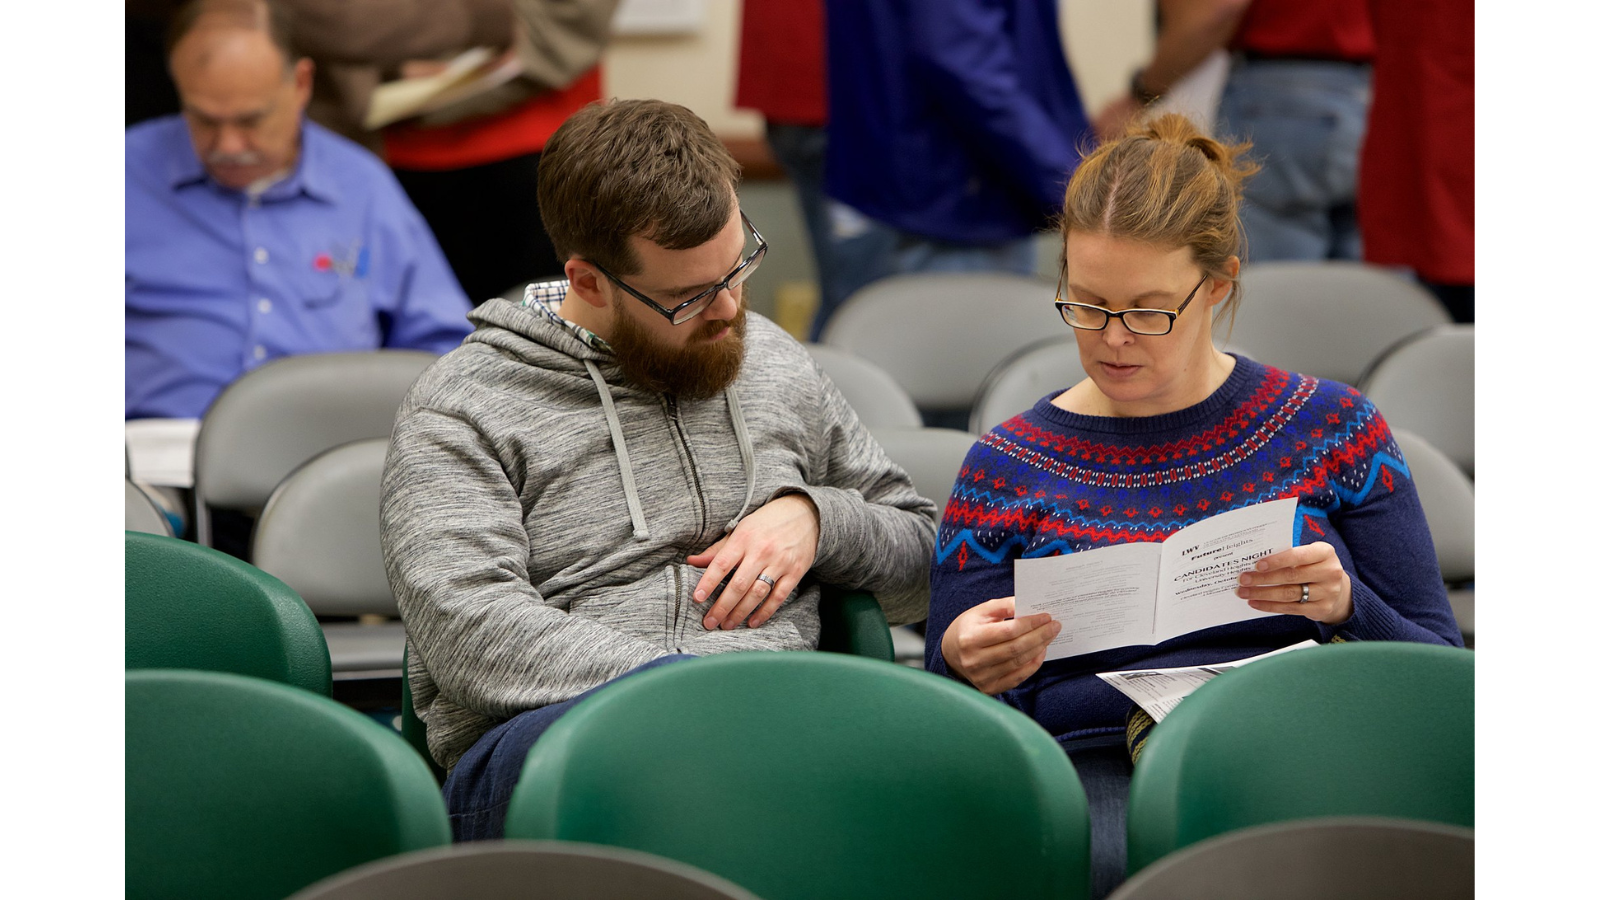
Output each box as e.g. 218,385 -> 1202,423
610,298 -> 744,400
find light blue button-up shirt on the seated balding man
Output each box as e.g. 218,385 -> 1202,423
125,115 -> 472,418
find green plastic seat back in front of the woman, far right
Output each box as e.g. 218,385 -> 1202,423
1128,641 -> 1474,874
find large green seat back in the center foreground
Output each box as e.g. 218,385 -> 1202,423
506,653 -> 1088,900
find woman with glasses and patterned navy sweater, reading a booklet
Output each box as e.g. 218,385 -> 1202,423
926,115 -> 1461,895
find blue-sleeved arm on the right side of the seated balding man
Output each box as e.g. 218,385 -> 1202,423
371,173 -> 472,354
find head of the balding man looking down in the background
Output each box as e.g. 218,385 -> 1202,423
166,0 -> 312,189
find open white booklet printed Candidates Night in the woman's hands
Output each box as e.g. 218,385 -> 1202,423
1016,496 -> 1299,660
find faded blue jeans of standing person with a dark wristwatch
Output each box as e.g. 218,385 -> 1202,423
1216,59 -> 1373,263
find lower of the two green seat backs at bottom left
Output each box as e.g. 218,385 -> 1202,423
125,669 -> 450,900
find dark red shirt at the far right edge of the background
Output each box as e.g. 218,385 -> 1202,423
1357,0 -> 1474,285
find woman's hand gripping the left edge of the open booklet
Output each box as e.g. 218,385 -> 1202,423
939,597 -> 1061,695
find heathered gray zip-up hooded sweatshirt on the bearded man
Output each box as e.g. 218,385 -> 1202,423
382,299 -> 934,769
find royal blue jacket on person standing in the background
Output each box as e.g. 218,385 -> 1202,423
827,0 -> 1090,243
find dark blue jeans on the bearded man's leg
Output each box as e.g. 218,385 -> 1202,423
445,653 -> 694,841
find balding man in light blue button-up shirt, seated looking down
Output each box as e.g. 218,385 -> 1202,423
125,0 -> 472,418
